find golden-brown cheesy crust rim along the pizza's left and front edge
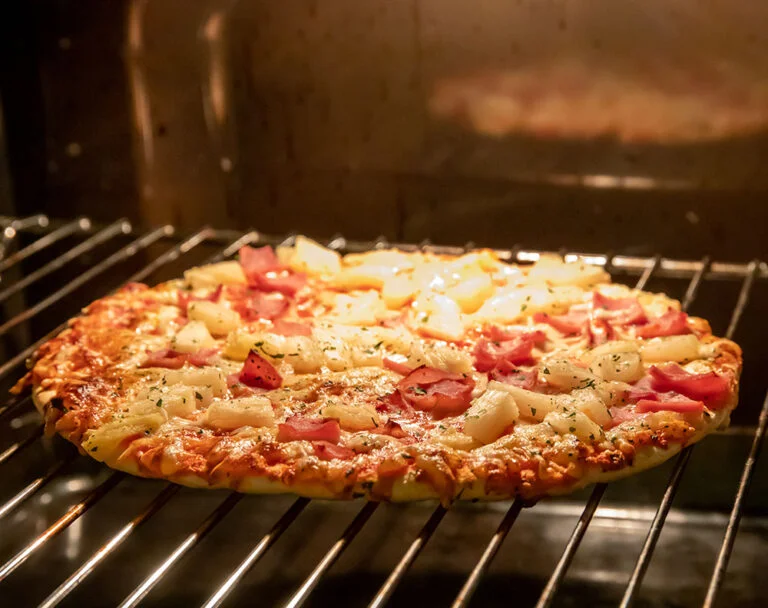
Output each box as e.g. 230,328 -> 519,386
16,252 -> 741,502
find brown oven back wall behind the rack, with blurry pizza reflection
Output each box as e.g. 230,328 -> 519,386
3,0 -> 768,259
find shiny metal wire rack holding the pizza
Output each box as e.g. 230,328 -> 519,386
0,215 -> 768,608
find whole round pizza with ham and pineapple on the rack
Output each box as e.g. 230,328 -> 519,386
14,237 -> 741,504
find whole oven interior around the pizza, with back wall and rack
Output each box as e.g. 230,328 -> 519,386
0,0 -> 768,608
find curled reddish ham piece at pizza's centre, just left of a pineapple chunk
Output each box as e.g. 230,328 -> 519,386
397,365 -> 475,419
